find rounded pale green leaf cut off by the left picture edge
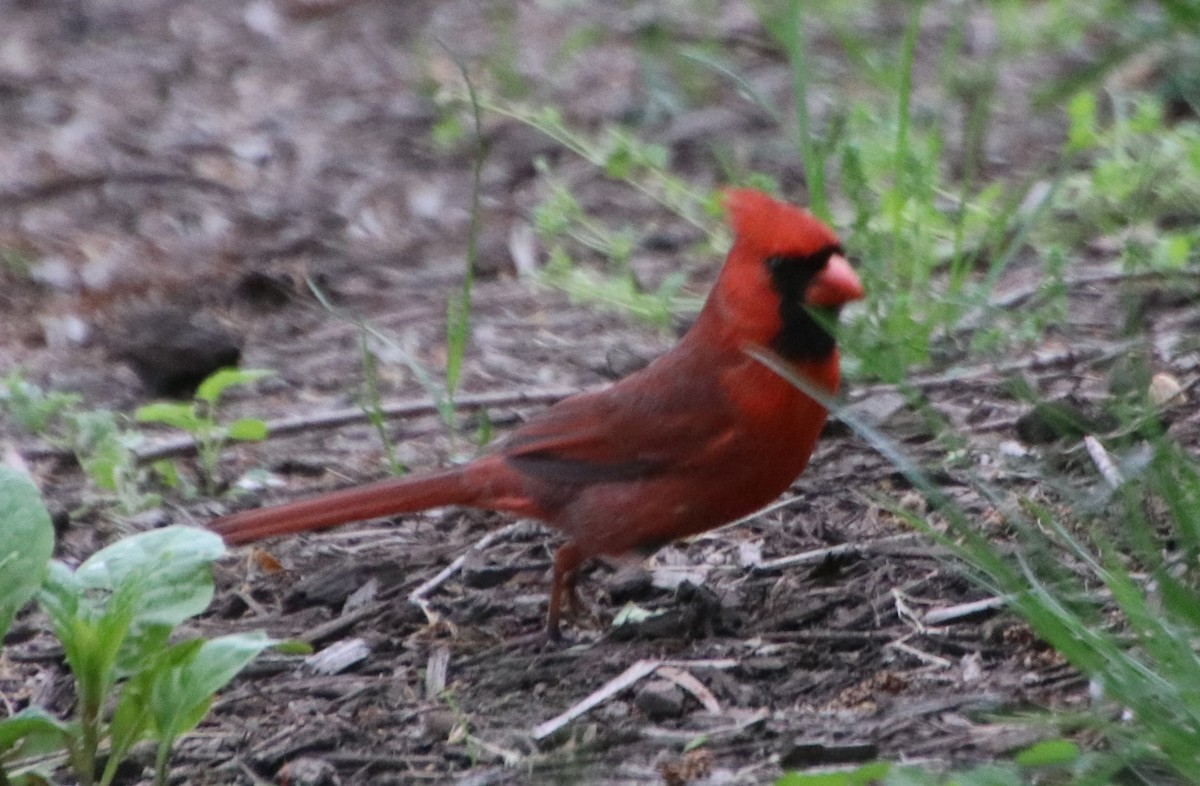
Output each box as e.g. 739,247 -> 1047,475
0,466 -> 54,638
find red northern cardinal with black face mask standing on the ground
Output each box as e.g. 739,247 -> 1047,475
211,188 -> 863,638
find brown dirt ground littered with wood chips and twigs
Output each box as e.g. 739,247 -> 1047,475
0,0 -> 1200,786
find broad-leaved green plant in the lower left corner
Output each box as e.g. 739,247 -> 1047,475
0,467 -> 283,786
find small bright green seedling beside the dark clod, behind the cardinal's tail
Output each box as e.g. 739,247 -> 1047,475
133,368 -> 275,494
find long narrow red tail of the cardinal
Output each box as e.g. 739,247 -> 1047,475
209,468 -> 479,546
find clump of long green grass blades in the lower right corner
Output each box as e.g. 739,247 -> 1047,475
856,427 -> 1200,784
